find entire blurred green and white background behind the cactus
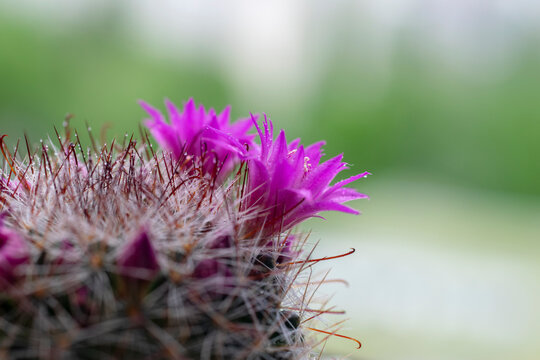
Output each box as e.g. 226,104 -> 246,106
0,0 -> 540,360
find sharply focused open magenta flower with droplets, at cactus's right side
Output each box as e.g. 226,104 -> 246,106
246,117 -> 370,235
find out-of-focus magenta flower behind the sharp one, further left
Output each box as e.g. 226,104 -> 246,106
139,99 -> 254,177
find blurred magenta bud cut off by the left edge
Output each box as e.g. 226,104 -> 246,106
0,215 -> 30,289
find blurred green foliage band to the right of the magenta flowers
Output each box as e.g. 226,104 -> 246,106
310,42 -> 540,195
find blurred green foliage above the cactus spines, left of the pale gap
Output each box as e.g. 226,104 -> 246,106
0,15 -> 227,141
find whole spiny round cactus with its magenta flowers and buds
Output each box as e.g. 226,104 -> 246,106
0,100 -> 367,360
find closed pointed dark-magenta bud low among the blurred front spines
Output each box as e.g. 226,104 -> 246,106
116,229 -> 160,280
